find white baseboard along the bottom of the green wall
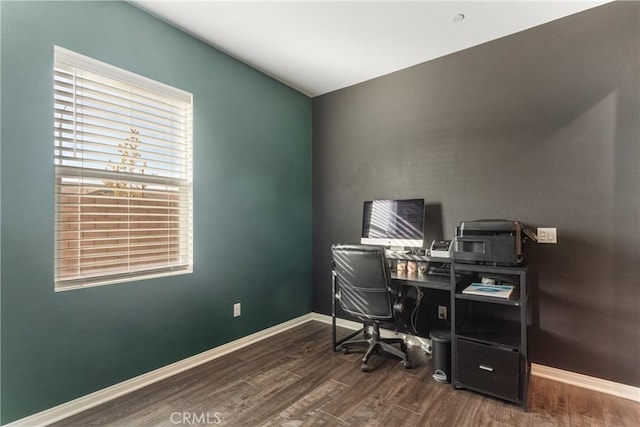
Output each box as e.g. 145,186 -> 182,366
6,313 -> 313,427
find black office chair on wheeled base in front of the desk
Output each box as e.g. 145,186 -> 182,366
331,245 -> 410,372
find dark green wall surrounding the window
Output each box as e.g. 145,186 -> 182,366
0,1 -> 312,424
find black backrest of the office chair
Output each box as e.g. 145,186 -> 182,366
331,245 -> 394,320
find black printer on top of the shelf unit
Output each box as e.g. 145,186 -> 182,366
451,219 -> 525,265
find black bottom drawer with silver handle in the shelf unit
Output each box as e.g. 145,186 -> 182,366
455,338 -> 520,401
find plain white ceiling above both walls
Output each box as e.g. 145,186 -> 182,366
131,0 -> 608,97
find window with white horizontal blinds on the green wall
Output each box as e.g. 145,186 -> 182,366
54,46 -> 193,290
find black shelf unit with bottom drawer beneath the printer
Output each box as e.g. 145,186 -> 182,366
451,262 -> 531,411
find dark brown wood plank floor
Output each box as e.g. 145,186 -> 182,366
54,322 -> 640,427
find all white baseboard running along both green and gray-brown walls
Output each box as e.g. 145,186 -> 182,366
6,312 -> 640,427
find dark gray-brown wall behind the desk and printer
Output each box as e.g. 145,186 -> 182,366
313,2 -> 640,386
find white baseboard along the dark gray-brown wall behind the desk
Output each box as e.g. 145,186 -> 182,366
311,313 -> 640,402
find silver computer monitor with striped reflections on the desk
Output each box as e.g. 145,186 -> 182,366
360,199 -> 424,248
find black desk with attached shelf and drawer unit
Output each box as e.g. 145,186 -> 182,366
332,254 -> 532,411
